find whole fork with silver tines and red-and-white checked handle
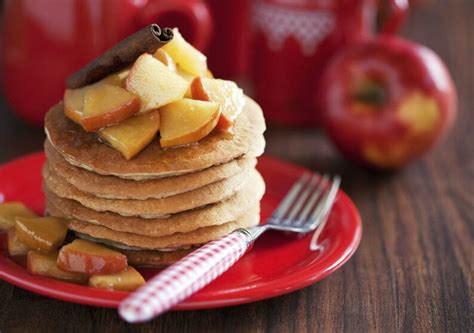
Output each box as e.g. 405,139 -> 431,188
118,172 -> 341,323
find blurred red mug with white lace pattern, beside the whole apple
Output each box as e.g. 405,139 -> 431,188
252,0 -> 408,126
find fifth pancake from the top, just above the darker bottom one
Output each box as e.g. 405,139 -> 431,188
64,204 -> 260,250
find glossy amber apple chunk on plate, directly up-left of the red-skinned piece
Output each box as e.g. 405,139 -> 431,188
15,216 -> 67,252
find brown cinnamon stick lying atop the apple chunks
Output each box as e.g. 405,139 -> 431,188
66,24 -> 173,89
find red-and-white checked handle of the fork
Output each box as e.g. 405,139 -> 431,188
119,229 -> 253,323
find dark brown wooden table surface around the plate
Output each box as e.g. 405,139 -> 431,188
0,0 -> 474,332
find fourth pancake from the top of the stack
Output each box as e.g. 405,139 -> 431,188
45,169 -> 265,237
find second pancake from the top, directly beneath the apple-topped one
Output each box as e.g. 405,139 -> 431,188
44,140 -> 257,200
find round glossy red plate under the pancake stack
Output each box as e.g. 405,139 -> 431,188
0,153 -> 362,310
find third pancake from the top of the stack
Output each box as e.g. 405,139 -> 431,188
43,163 -> 257,218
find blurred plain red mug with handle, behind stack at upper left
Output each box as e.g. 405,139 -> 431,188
0,0 -> 212,125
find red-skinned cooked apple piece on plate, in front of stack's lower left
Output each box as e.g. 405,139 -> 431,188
58,239 -> 128,275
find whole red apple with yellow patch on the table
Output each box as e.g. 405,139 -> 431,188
318,36 -> 457,169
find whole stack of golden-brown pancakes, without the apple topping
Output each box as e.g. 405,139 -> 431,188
43,98 -> 265,266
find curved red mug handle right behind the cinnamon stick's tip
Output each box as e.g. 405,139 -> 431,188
139,0 -> 213,50
